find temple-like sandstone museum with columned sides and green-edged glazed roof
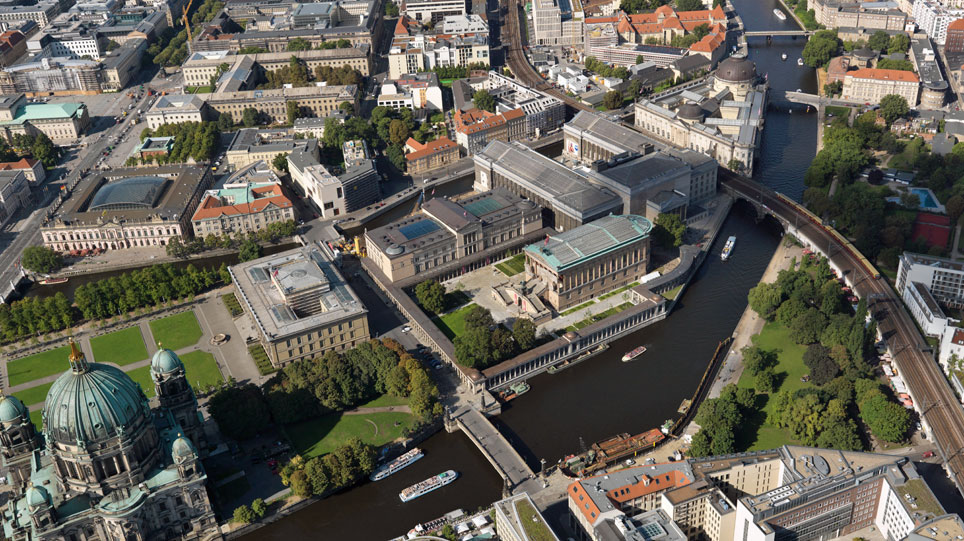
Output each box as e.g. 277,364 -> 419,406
524,214 -> 653,312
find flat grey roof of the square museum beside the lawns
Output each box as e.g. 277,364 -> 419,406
228,245 -> 368,341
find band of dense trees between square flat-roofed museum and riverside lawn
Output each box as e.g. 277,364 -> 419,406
210,339 -> 442,440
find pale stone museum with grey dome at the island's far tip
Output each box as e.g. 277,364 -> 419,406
635,57 -> 767,175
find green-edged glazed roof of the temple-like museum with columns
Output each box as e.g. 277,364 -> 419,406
525,214 -> 653,272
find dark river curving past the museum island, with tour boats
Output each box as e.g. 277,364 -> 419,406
246,0 -> 816,541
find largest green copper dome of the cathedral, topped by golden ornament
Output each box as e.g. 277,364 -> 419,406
44,362 -> 150,445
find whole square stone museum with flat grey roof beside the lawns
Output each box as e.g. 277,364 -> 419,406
228,244 -> 371,368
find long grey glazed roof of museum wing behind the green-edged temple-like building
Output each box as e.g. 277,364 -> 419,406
475,141 -> 622,221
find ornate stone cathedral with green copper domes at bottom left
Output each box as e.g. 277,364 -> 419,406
0,340 -> 221,541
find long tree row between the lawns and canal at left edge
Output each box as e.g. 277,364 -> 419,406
0,264 -> 231,342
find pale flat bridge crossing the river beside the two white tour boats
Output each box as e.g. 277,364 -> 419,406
448,406 -> 542,494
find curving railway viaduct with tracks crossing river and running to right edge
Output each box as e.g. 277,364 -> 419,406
720,168 -> 964,494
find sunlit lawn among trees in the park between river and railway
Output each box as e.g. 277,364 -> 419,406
737,322 -> 812,451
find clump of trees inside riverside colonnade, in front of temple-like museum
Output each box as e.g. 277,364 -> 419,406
453,305 -> 536,370
